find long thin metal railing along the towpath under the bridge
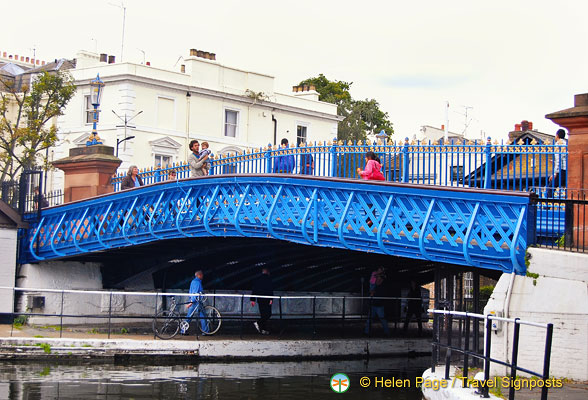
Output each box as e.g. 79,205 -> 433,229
5,287 -> 429,338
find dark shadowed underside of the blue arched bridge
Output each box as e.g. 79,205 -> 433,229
72,238 -> 500,294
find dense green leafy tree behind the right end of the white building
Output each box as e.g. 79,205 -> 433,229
300,74 -> 394,141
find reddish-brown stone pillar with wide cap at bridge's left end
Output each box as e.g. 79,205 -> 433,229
53,145 -> 121,203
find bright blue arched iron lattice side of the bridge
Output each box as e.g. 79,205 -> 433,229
20,174 -> 536,274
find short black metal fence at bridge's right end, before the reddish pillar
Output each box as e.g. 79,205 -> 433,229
535,189 -> 588,252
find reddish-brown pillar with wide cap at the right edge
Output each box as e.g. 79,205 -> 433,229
545,93 -> 588,248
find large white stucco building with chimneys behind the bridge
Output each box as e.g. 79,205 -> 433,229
49,50 -> 339,192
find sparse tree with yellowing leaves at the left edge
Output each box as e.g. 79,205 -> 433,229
0,72 -> 76,181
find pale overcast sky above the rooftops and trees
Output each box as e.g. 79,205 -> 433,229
0,0 -> 588,138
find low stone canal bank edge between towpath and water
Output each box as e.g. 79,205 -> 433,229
0,337 -> 431,362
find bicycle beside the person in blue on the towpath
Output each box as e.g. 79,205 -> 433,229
153,296 -> 221,340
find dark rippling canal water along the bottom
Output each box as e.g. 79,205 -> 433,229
0,357 -> 431,400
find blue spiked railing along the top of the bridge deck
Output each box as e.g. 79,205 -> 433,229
112,140 -> 567,197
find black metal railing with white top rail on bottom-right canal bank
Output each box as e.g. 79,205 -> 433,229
429,310 -> 553,400
